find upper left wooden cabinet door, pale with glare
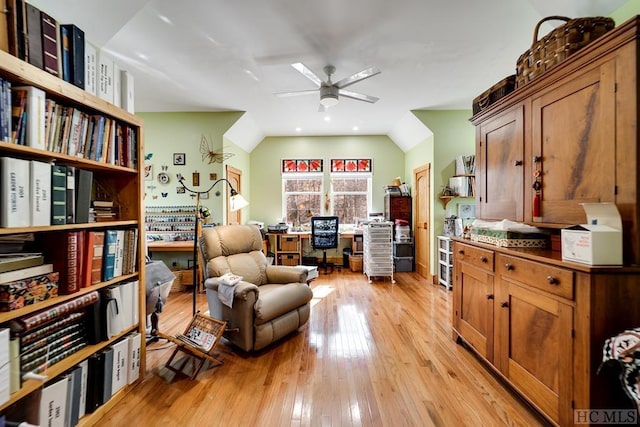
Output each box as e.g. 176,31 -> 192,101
476,105 -> 524,221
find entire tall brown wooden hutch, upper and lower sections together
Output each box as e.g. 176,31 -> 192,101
460,17 -> 640,426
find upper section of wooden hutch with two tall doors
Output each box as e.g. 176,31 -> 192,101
471,17 -> 640,264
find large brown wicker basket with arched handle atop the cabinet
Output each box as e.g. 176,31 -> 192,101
516,16 -> 615,88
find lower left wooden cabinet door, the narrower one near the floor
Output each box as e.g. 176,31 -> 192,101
453,261 -> 493,362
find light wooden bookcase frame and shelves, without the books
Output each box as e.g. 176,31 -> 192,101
0,51 -> 146,425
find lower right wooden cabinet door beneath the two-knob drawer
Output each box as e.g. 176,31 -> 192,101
495,276 -> 573,425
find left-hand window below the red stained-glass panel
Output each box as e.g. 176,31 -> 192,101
282,173 -> 322,226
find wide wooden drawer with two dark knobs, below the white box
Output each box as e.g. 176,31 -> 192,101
496,255 -> 573,299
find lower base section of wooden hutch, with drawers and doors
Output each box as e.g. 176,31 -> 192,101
453,239 -> 640,426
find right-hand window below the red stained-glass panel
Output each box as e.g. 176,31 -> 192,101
331,173 -> 371,224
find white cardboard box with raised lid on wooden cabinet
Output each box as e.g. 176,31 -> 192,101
561,203 -> 622,265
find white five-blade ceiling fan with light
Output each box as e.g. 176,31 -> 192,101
276,62 -> 380,111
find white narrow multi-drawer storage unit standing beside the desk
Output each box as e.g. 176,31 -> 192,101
364,221 -> 396,283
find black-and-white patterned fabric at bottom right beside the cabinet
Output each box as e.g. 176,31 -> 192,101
598,328 -> 640,411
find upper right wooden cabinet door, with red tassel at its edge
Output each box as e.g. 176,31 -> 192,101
528,61 -> 616,224
